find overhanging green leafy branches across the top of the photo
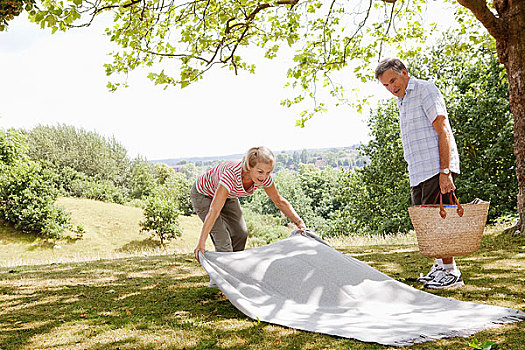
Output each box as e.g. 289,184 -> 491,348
15,0 -> 484,126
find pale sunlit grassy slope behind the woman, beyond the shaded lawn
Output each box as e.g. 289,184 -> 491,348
0,197 -> 212,267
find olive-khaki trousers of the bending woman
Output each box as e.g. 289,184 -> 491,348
190,184 -> 248,252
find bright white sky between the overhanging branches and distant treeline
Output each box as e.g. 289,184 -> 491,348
0,11 -> 406,160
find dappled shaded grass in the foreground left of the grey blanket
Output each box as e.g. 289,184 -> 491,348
0,255 -> 383,350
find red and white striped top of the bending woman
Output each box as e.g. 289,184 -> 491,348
195,161 -> 273,198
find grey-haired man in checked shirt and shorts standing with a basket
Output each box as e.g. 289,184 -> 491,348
375,58 -> 464,289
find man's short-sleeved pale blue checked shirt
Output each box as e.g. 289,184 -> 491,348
397,77 -> 459,187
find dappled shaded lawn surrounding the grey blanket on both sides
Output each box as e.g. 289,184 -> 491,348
0,198 -> 525,350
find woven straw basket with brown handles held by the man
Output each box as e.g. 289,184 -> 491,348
408,193 -> 490,258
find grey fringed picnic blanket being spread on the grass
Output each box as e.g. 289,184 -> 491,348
200,231 -> 525,346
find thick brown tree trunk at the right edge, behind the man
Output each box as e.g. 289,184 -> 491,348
458,0 -> 525,234
